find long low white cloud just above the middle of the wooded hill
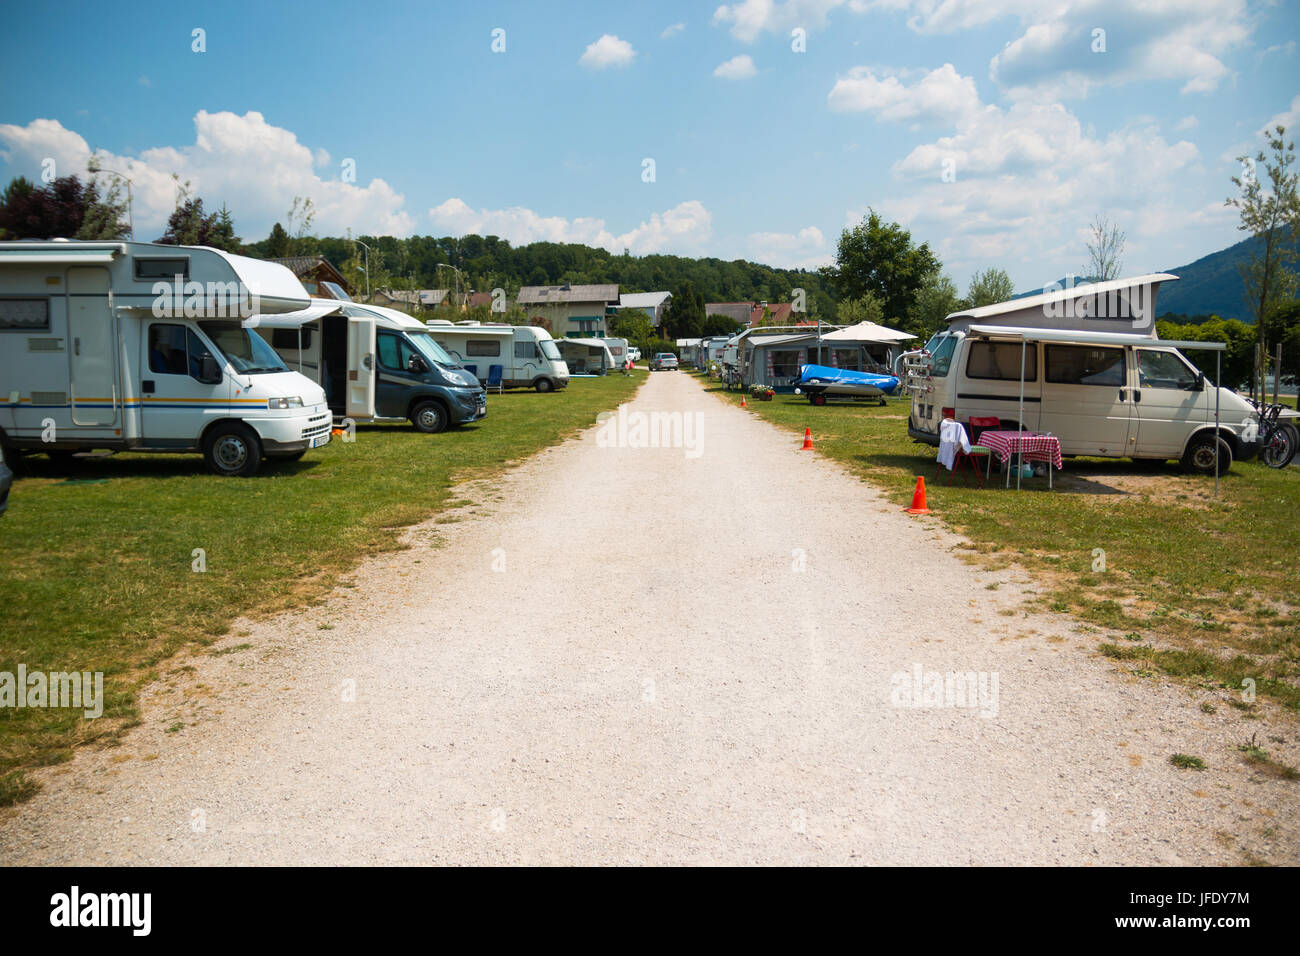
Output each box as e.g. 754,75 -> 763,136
429,198 -> 712,255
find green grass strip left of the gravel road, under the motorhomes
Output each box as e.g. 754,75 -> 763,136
0,375 -> 645,805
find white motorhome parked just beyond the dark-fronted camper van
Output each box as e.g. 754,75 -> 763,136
429,319 -> 569,392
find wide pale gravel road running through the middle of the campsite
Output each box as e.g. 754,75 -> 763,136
0,372 -> 1300,865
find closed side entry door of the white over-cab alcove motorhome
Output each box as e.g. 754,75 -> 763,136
68,265 -> 121,425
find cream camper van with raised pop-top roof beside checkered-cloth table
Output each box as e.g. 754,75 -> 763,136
906,273 -> 1258,475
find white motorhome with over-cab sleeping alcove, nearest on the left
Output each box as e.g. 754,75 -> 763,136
0,239 -> 330,475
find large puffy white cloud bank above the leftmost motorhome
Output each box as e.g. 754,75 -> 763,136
0,111 -> 413,239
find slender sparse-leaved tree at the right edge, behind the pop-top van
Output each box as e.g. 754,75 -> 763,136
1227,125 -> 1300,390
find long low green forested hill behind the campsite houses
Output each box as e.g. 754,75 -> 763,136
246,235 -> 835,315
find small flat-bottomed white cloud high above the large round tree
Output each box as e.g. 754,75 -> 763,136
827,64 -> 979,121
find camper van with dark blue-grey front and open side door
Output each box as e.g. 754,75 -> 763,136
247,299 -> 488,433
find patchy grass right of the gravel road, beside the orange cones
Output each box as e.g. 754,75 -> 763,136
702,377 -> 1300,713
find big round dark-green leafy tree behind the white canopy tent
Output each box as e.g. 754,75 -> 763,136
823,209 -> 940,321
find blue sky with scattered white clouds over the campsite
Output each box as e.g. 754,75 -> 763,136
0,0 -> 1300,289
